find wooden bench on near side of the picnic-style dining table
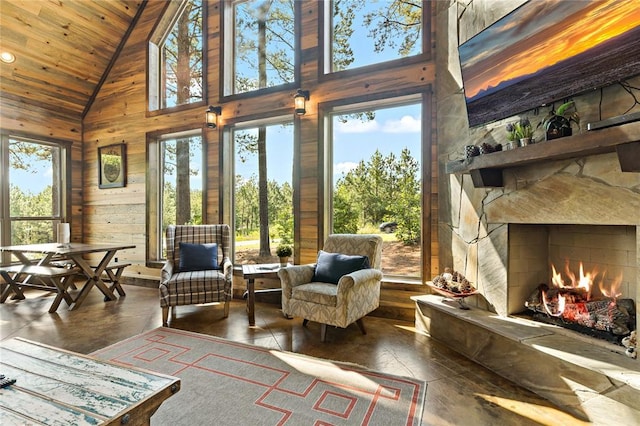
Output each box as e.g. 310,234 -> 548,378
0,265 -> 79,313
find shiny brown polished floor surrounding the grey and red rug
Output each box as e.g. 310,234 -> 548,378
0,285 -> 584,425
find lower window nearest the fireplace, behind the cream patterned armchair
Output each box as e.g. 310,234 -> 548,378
327,100 -> 422,277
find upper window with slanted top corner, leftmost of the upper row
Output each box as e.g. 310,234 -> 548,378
149,0 -> 204,110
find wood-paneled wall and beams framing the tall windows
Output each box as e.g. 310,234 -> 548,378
3,0 -> 438,316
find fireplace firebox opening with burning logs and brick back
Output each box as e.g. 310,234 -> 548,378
507,224 -> 638,345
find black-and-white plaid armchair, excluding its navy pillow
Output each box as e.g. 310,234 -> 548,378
160,224 -> 233,327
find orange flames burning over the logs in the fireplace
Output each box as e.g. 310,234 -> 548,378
542,261 -> 622,317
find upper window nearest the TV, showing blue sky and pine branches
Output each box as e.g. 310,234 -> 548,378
325,0 -> 423,73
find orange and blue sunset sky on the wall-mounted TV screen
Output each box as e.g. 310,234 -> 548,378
460,0 -> 640,99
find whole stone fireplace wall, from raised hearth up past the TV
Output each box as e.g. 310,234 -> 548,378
430,0 -> 640,424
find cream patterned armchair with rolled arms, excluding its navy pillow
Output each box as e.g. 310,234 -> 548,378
278,234 -> 382,342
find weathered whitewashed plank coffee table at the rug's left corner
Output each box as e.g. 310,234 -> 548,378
0,337 -> 180,426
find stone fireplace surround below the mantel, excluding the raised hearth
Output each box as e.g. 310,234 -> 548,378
442,148 -> 640,334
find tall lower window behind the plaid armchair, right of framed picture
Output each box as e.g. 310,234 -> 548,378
147,130 -> 205,260
